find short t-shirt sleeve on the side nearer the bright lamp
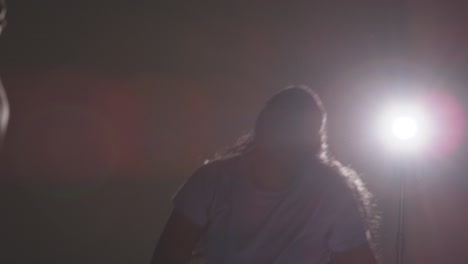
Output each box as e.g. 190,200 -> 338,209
328,186 -> 367,252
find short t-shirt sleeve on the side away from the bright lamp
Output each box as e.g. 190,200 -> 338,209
172,165 -> 214,227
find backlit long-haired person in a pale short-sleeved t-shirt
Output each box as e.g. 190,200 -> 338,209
152,87 -> 376,264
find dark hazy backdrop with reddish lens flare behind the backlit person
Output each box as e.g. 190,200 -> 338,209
0,0 -> 468,263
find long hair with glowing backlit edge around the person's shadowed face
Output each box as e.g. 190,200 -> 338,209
207,86 -> 380,253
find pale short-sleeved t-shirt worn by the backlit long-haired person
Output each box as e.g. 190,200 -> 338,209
173,158 -> 367,264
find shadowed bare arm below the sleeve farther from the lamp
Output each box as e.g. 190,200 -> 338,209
151,211 -> 202,264
